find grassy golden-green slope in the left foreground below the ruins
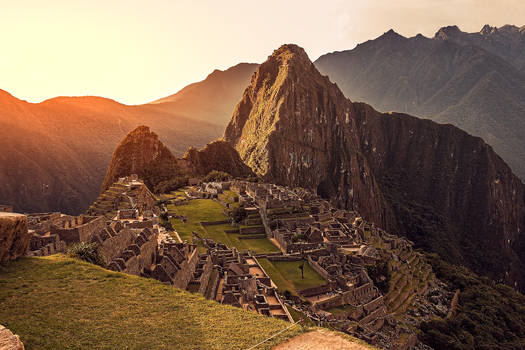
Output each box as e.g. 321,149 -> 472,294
0,255 -> 302,350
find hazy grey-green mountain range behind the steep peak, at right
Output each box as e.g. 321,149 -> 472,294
315,25 -> 525,179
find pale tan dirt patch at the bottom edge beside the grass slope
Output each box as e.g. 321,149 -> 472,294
272,330 -> 370,350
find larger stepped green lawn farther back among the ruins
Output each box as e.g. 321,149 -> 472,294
168,199 -> 279,253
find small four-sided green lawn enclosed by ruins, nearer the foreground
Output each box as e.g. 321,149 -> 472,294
259,259 -> 327,295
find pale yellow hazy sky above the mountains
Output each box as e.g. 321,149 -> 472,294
0,0 -> 525,104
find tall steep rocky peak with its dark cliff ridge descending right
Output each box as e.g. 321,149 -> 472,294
224,45 -> 525,287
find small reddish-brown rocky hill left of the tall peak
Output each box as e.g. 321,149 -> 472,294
102,126 -> 181,191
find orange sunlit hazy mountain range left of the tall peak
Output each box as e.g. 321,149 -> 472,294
0,64 -> 257,214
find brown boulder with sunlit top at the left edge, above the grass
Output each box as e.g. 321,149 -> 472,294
0,212 -> 31,262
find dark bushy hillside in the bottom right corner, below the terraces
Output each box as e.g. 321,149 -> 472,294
421,255 -> 525,350
